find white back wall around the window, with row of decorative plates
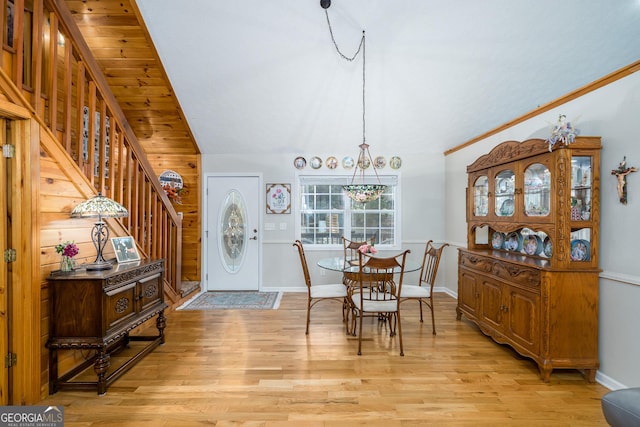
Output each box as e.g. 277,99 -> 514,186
202,150 -> 444,291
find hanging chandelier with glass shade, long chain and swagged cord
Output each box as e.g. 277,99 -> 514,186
320,0 -> 387,203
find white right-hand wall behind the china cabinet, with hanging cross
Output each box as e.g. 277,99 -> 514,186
445,73 -> 640,388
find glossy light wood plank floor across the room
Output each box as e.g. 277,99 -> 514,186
40,293 -> 608,427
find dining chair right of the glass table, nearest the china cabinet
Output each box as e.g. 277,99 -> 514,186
400,240 -> 449,335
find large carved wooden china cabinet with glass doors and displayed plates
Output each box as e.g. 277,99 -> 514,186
456,137 -> 601,382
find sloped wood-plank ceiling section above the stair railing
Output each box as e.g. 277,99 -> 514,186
64,0 -> 200,155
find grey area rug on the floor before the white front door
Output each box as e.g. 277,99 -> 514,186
180,291 -> 282,310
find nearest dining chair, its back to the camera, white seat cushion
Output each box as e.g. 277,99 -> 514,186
347,250 -> 411,356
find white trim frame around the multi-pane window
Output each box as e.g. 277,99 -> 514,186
292,171 -> 402,251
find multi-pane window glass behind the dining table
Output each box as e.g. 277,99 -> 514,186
296,176 -> 400,248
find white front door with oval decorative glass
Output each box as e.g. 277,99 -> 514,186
203,175 -> 262,291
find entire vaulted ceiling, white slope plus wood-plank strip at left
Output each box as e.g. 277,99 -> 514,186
66,0 -> 640,154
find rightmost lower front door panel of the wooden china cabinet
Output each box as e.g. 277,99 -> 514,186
507,288 -> 540,353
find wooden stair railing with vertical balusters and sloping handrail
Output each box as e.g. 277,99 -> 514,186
0,0 -> 182,295
